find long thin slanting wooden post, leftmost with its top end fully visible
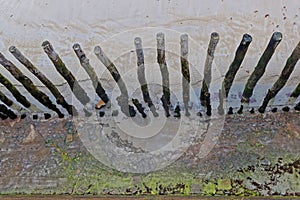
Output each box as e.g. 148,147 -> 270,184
9,46 -> 77,115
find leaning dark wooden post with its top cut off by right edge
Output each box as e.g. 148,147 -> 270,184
258,42 -> 300,113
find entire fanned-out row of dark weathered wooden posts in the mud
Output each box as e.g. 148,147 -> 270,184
0,32 -> 300,119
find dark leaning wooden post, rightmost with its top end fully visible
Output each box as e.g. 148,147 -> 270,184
242,32 -> 282,102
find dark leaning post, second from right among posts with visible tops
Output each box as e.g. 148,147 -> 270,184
223,34 -> 252,98
